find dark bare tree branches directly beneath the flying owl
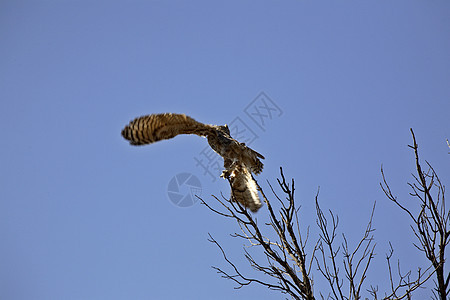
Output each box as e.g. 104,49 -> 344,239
200,170 -> 314,300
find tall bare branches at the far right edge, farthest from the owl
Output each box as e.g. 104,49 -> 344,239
380,129 -> 450,300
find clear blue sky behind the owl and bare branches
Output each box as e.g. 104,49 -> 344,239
0,0 -> 450,299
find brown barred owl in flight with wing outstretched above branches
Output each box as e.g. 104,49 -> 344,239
122,113 -> 264,212
